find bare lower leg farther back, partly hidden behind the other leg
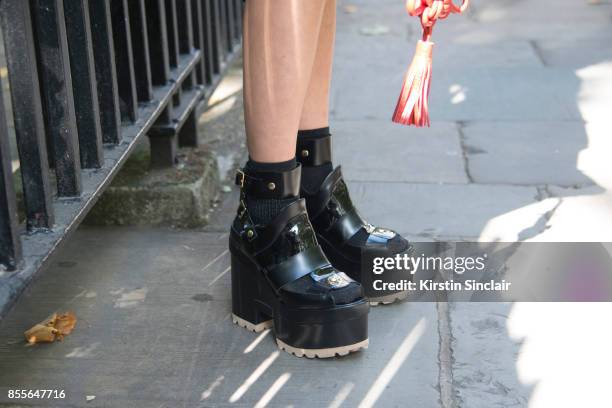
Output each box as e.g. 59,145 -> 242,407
300,0 -> 336,130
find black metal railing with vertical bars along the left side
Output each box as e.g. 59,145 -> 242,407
0,0 -> 242,313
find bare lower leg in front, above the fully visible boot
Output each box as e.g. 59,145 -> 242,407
244,0 -> 331,162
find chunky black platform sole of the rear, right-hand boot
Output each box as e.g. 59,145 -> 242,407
317,234 -> 414,306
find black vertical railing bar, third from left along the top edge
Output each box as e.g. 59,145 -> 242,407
64,0 -> 104,168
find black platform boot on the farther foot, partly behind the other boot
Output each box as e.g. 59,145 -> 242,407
296,136 -> 414,305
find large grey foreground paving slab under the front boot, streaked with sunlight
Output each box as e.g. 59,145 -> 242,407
0,227 -> 439,407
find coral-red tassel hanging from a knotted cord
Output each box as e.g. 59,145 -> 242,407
393,0 -> 469,126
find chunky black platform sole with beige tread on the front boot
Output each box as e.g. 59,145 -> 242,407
230,248 -> 369,358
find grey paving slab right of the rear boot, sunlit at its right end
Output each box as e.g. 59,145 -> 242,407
349,182 -> 549,239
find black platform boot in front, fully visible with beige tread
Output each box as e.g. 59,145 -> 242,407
229,165 -> 369,358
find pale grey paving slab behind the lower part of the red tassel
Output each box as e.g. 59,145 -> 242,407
334,65 -> 582,122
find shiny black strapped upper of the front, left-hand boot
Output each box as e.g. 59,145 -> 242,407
230,167 -> 362,305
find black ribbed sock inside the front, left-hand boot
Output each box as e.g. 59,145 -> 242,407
245,157 -> 297,225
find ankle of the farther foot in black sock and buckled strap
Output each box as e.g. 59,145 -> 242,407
296,127 -> 334,192
